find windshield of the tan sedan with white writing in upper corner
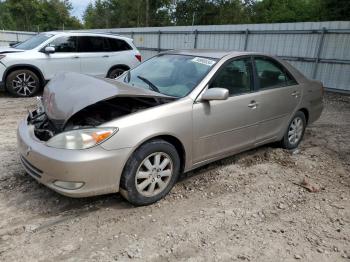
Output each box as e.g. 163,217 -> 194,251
122,55 -> 217,97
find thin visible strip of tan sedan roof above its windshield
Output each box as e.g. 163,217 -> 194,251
163,49 -> 253,59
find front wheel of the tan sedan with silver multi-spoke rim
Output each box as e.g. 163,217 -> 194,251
120,139 -> 180,206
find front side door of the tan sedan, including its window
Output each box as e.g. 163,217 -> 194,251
193,57 -> 258,164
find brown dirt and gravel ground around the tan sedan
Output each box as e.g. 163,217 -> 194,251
0,91 -> 350,262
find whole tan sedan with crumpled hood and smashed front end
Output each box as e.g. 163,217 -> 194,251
17,50 -> 323,205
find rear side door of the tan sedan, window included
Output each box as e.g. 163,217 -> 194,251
254,56 -> 301,145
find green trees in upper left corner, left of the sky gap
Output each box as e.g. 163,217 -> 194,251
0,0 -> 82,31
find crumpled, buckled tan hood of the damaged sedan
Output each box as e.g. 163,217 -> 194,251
42,73 -> 168,125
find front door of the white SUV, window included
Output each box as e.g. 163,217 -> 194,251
42,36 -> 80,79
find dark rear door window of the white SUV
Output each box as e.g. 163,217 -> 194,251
78,36 -> 109,52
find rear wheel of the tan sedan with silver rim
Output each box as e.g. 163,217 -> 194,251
281,111 -> 306,149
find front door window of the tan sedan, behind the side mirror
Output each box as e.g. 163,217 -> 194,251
209,57 -> 253,96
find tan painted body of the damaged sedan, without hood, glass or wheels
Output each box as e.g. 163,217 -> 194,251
18,51 -> 322,197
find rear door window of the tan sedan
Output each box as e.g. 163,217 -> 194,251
254,58 -> 297,89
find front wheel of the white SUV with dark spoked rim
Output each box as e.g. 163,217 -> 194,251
6,69 -> 40,97
